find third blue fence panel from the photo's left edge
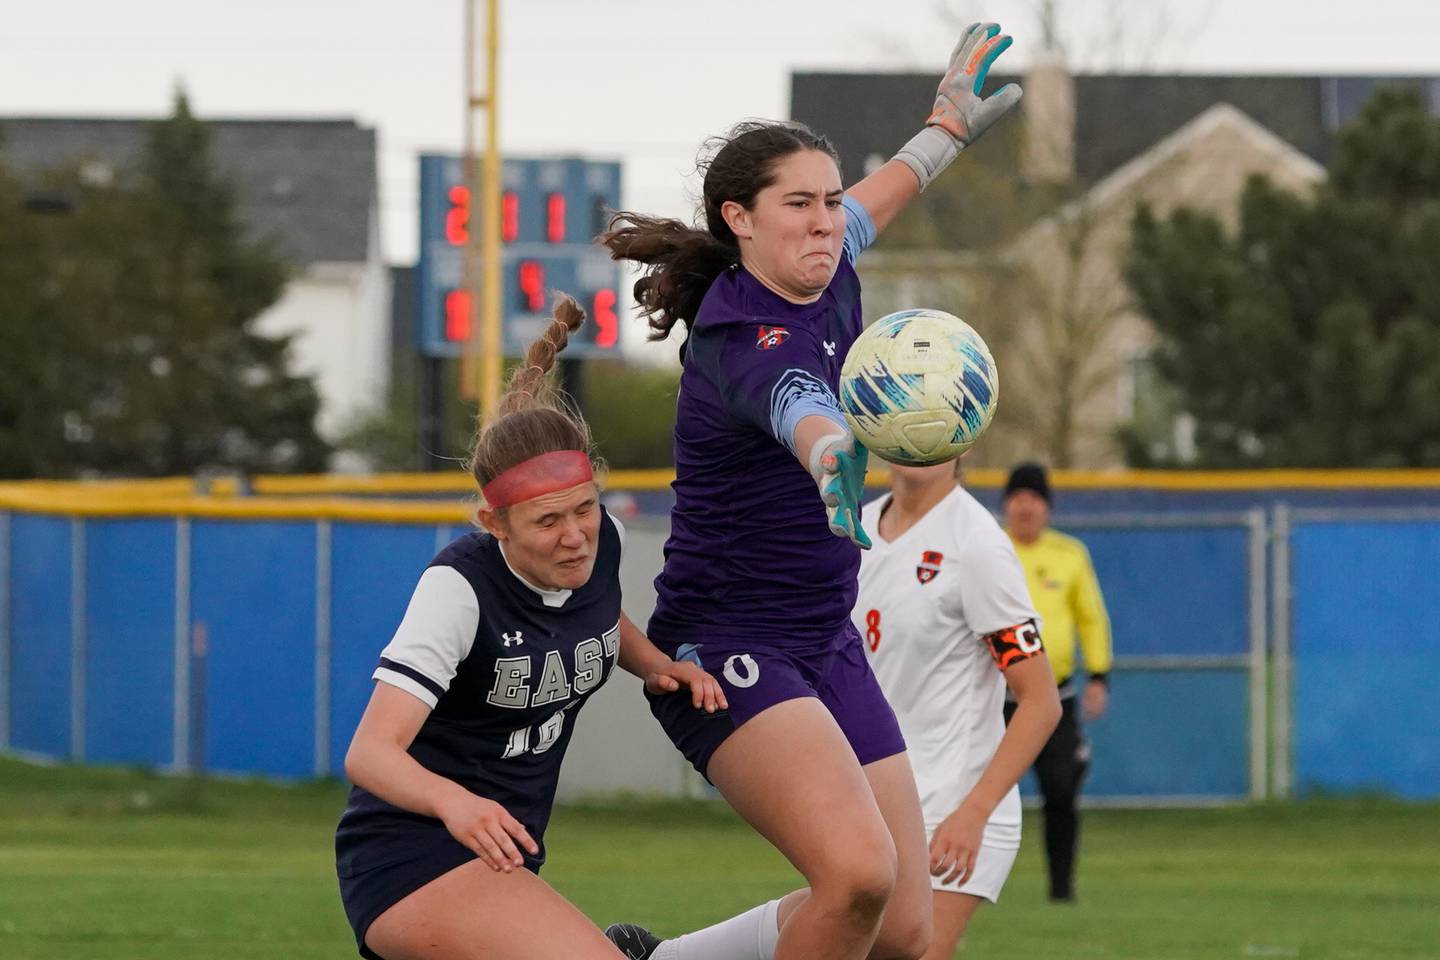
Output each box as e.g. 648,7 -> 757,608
190,521 -> 315,777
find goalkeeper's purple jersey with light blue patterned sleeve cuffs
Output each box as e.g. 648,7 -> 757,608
649,228 -> 873,646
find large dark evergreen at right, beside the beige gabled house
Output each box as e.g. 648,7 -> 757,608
1128,88 -> 1440,468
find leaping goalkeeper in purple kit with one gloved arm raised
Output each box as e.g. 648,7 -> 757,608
602,23 -> 1020,960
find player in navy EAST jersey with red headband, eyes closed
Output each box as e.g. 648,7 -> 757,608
336,299 -> 726,960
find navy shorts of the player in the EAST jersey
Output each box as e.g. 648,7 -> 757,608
336,816 -> 544,960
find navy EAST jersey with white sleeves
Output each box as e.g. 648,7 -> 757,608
336,508 -> 624,872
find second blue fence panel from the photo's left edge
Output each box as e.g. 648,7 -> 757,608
85,518 -> 176,766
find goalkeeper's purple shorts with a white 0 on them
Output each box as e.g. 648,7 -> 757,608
645,623 -> 904,779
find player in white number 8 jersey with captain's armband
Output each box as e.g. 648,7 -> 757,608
852,463 -> 1060,960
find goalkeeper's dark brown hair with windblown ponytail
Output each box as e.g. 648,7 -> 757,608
599,119 -> 840,340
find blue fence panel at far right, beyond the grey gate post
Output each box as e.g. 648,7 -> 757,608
1292,521 -> 1440,799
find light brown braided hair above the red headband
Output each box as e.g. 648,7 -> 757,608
469,294 -> 595,500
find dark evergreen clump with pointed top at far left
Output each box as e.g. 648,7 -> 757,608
0,94 -> 328,476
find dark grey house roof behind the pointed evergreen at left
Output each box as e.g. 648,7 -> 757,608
0,117 -> 376,265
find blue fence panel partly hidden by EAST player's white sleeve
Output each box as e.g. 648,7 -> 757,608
330,524 -> 438,776
